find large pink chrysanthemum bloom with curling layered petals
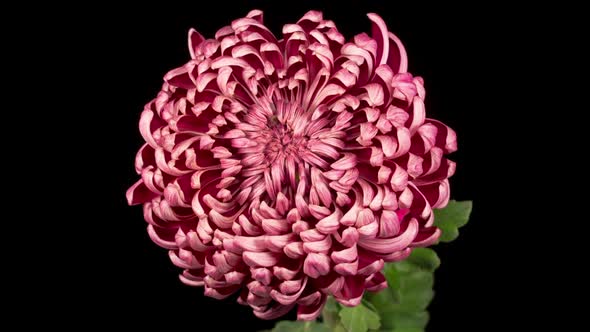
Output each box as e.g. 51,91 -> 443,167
127,10 -> 456,319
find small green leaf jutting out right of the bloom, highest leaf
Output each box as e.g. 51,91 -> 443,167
434,200 -> 473,242
